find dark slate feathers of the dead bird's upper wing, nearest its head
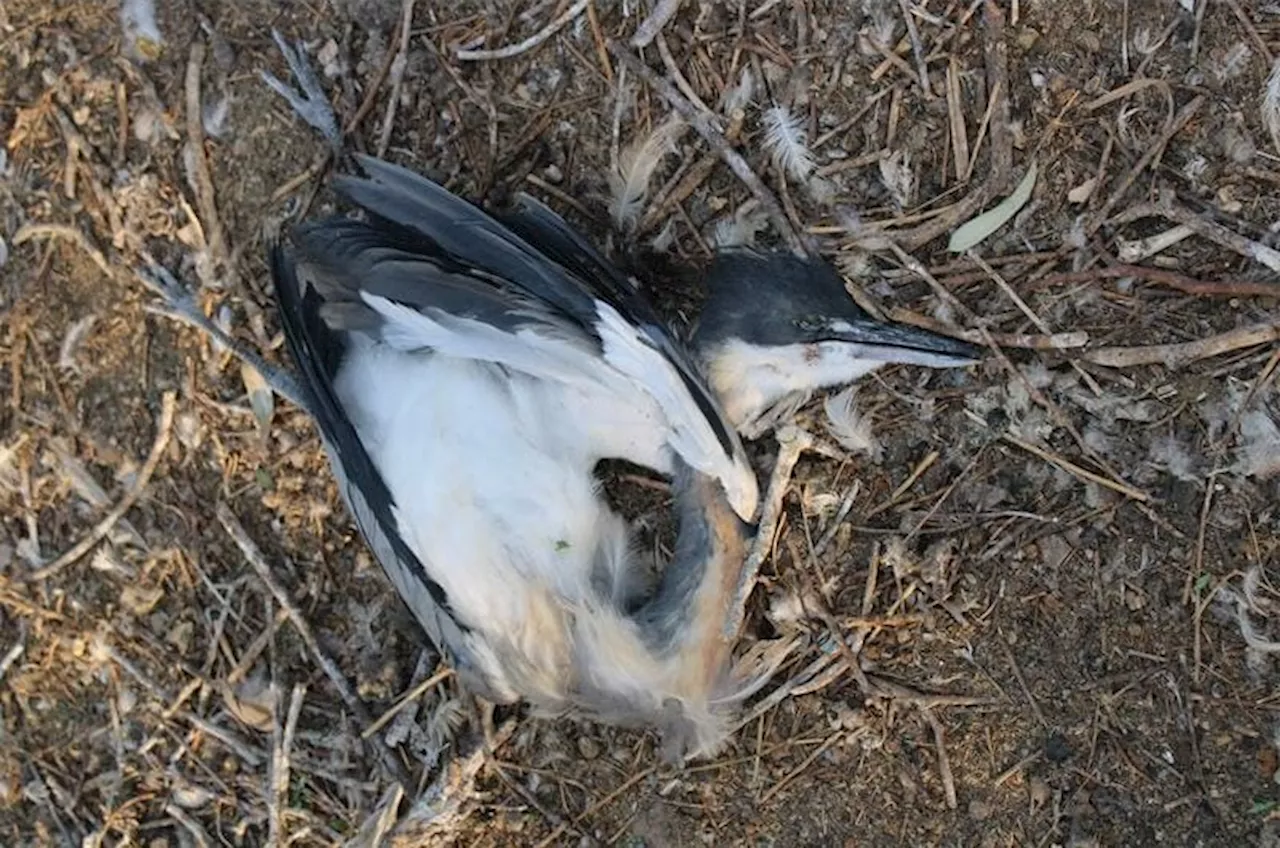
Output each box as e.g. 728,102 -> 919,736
318,156 -> 746,481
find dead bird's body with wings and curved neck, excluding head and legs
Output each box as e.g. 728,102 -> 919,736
271,158 -> 758,751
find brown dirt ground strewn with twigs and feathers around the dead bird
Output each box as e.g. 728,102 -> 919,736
0,0 -> 1280,847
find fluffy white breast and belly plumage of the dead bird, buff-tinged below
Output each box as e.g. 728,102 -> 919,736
335,336 -> 719,740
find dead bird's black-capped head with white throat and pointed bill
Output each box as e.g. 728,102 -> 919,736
692,247 -> 979,438
